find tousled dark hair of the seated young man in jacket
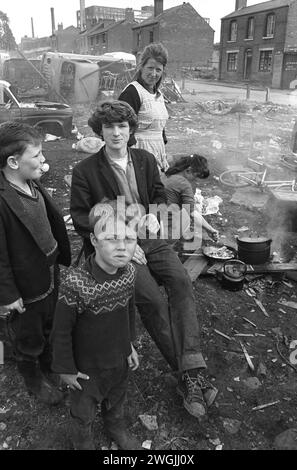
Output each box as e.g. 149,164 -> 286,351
88,100 -> 137,137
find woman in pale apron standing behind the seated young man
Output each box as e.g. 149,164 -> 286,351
118,43 -> 169,172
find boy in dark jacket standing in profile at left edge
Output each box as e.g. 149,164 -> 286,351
0,122 -> 71,404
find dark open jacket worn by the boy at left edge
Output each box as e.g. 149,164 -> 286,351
0,171 -> 71,305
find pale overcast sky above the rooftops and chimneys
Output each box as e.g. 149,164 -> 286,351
0,0 -> 260,42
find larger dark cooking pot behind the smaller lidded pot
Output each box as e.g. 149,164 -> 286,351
237,237 -> 272,264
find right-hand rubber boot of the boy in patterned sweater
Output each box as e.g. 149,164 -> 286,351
101,404 -> 143,450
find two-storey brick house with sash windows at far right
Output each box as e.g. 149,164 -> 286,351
220,0 -> 297,88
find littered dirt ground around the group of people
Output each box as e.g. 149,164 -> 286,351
0,94 -> 297,450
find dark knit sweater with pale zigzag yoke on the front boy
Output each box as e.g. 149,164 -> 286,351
52,255 -> 136,374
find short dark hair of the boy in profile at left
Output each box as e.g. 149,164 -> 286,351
0,121 -> 43,168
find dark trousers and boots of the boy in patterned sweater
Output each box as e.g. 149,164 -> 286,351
70,358 -> 141,450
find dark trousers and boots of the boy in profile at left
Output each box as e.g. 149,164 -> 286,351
8,272 -> 63,404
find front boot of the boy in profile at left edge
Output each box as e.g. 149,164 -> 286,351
17,361 -> 64,405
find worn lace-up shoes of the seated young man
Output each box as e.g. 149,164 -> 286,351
177,372 -> 218,419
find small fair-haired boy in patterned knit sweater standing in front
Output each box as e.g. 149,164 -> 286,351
52,201 -> 141,450
